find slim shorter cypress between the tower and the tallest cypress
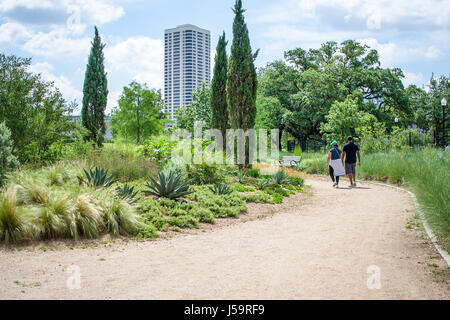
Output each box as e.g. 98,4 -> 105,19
211,32 -> 228,137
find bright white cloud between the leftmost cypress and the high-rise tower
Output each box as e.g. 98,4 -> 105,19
105,37 -> 164,88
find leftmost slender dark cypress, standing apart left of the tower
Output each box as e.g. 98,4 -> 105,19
81,27 -> 108,145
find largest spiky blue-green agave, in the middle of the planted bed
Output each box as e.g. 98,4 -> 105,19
143,171 -> 194,199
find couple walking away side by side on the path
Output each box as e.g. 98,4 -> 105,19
327,137 -> 361,188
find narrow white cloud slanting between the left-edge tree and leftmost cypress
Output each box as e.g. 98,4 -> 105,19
30,62 -> 83,104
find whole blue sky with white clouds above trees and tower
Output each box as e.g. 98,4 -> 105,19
0,0 -> 450,113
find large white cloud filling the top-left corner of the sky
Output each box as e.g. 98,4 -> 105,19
0,0 -> 124,59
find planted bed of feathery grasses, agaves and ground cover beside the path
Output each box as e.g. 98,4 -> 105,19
0,138 -> 303,245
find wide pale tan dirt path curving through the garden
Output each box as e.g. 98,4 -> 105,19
0,178 -> 450,299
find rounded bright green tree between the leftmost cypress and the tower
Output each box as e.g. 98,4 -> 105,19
111,81 -> 165,144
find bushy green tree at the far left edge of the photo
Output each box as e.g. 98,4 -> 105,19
0,54 -> 76,162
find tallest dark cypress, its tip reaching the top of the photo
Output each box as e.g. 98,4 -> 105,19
227,0 -> 258,130
